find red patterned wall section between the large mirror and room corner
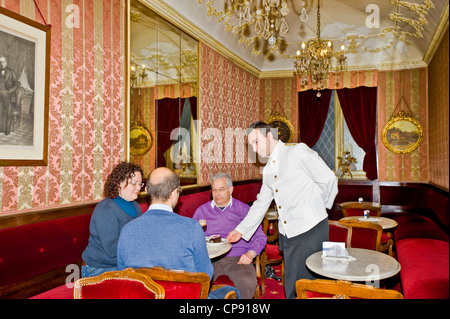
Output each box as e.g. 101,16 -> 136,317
199,43 -> 260,185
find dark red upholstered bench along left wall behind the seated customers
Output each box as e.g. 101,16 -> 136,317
0,181 -> 261,299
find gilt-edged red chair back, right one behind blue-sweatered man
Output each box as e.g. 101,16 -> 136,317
136,266 -> 210,299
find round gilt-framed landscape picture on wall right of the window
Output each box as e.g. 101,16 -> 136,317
381,111 -> 423,154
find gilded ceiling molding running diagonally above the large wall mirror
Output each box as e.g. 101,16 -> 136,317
140,0 -> 261,77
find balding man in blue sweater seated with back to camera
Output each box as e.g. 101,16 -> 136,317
117,167 -> 241,299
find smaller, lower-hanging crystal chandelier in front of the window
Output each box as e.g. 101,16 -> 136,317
294,0 -> 347,94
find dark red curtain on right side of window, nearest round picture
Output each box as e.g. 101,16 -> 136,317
337,86 -> 378,180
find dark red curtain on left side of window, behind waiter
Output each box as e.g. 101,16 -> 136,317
298,89 -> 331,147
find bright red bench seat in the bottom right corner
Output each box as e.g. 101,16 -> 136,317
396,238 -> 449,299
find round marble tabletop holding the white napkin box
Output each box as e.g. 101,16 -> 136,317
306,248 -> 401,282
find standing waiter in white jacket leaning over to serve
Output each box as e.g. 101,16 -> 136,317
227,121 -> 338,299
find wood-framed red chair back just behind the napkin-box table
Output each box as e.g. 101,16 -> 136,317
339,219 -> 383,251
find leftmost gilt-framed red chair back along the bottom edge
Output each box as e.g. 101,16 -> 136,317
74,268 -> 164,299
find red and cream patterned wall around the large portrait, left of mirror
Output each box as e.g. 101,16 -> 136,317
0,0 -> 125,215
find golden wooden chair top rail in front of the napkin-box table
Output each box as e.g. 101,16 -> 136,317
295,279 -> 403,299
